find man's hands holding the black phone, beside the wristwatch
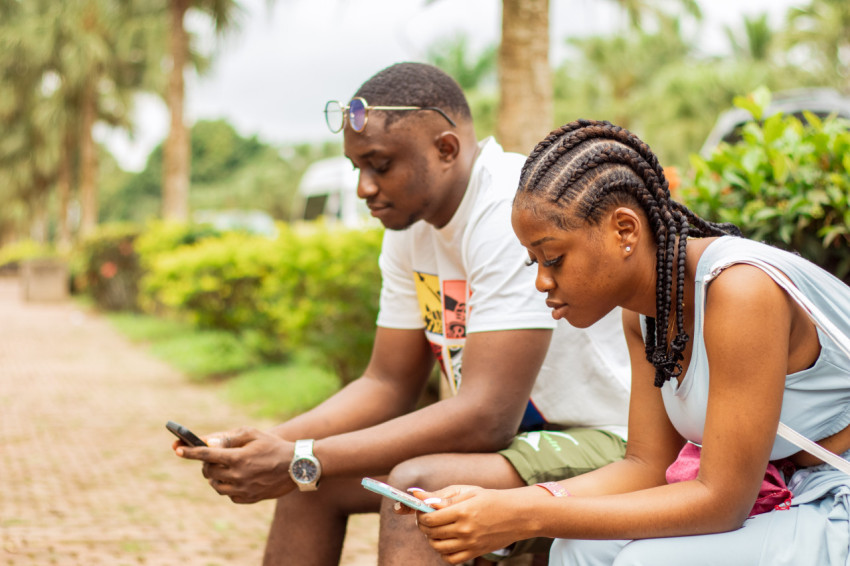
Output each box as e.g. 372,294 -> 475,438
175,428 -> 295,503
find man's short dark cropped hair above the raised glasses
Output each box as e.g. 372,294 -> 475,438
354,63 -> 472,126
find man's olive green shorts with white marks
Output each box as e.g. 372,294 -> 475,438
486,428 -> 626,560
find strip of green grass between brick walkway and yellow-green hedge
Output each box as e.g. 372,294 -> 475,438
106,313 -> 340,418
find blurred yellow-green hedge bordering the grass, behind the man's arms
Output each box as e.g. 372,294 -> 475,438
141,224 -> 381,382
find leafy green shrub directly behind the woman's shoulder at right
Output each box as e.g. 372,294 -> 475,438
682,89 -> 850,283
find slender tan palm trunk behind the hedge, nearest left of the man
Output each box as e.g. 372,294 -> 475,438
162,0 -> 191,220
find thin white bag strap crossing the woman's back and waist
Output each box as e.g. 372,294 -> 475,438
711,259 -> 850,475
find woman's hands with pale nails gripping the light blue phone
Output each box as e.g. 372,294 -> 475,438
414,485 -> 526,564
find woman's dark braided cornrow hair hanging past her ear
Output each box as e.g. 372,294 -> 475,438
515,120 -> 740,387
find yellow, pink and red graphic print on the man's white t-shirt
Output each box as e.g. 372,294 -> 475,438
413,271 -> 468,393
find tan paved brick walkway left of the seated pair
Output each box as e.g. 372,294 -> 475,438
0,278 -> 377,566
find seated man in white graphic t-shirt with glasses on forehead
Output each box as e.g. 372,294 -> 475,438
178,63 -> 628,565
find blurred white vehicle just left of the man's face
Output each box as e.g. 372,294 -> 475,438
293,157 -> 378,228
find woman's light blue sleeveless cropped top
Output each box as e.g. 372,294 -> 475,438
660,236 -> 850,460
